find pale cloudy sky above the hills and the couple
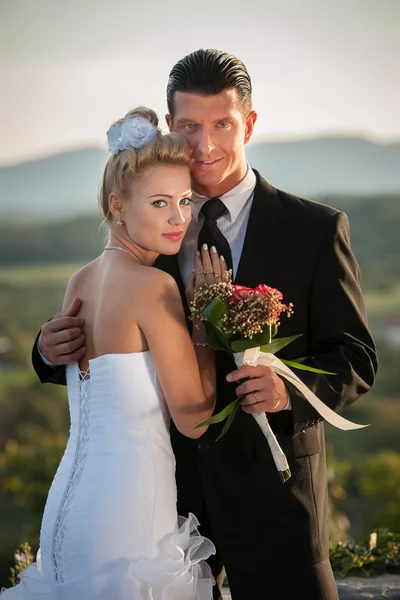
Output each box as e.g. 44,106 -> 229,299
0,0 -> 400,165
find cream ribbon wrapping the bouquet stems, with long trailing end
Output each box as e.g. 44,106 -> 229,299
234,348 -> 368,481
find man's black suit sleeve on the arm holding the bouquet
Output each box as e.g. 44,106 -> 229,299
288,212 -> 377,435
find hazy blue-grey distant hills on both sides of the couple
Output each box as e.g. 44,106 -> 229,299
0,138 -> 400,220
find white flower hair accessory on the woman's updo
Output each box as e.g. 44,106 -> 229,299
107,116 -> 157,154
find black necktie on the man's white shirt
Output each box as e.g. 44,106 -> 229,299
198,198 -> 232,269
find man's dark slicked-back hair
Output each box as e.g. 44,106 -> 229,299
167,49 -> 252,116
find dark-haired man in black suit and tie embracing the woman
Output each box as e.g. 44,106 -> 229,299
33,50 -> 377,600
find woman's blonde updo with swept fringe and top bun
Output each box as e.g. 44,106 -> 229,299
99,106 -> 189,224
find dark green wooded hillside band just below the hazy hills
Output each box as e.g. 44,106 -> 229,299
0,195 -> 400,290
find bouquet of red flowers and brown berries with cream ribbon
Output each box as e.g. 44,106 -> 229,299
190,271 -> 365,483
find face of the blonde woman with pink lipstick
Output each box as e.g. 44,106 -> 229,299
121,164 -> 192,255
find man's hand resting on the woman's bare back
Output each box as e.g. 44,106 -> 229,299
38,298 -> 86,365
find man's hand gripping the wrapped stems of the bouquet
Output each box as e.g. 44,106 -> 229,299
226,365 -> 288,414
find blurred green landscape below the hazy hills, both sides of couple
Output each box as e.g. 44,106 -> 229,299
0,197 -> 400,588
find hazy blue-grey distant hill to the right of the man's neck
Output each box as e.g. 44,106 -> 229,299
247,137 -> 400,198
